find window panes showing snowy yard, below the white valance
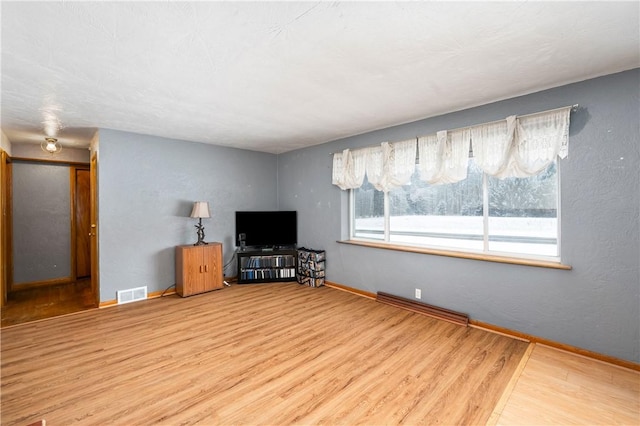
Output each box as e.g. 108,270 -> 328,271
351,159 -> 559,260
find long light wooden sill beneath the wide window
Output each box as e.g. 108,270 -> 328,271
338,240 -> 571,270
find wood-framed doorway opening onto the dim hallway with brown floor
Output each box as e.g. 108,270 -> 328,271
2,158 -> 99,327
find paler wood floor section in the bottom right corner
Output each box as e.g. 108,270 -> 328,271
497,345 -> 640,425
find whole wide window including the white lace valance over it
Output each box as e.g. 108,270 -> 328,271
332,105 -> 577,263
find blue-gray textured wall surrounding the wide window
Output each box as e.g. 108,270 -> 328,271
278,69 -> 640,362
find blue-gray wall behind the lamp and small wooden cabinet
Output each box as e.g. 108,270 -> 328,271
98,129 -> 277,301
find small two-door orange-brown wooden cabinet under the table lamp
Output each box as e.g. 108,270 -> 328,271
176,243 -> 224,297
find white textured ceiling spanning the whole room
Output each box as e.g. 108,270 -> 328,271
0,1 -> 640,153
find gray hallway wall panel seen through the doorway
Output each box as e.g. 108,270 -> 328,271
12,161 -> 71,286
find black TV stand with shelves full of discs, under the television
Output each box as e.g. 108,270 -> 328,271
238,247 -> 298,284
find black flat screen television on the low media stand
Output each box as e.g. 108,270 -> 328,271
236,211 -> 298,248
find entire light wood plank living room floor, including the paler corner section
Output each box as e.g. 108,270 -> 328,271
0,283 -> 640,425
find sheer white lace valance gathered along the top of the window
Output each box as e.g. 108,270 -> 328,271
332,107 -> 572,192
